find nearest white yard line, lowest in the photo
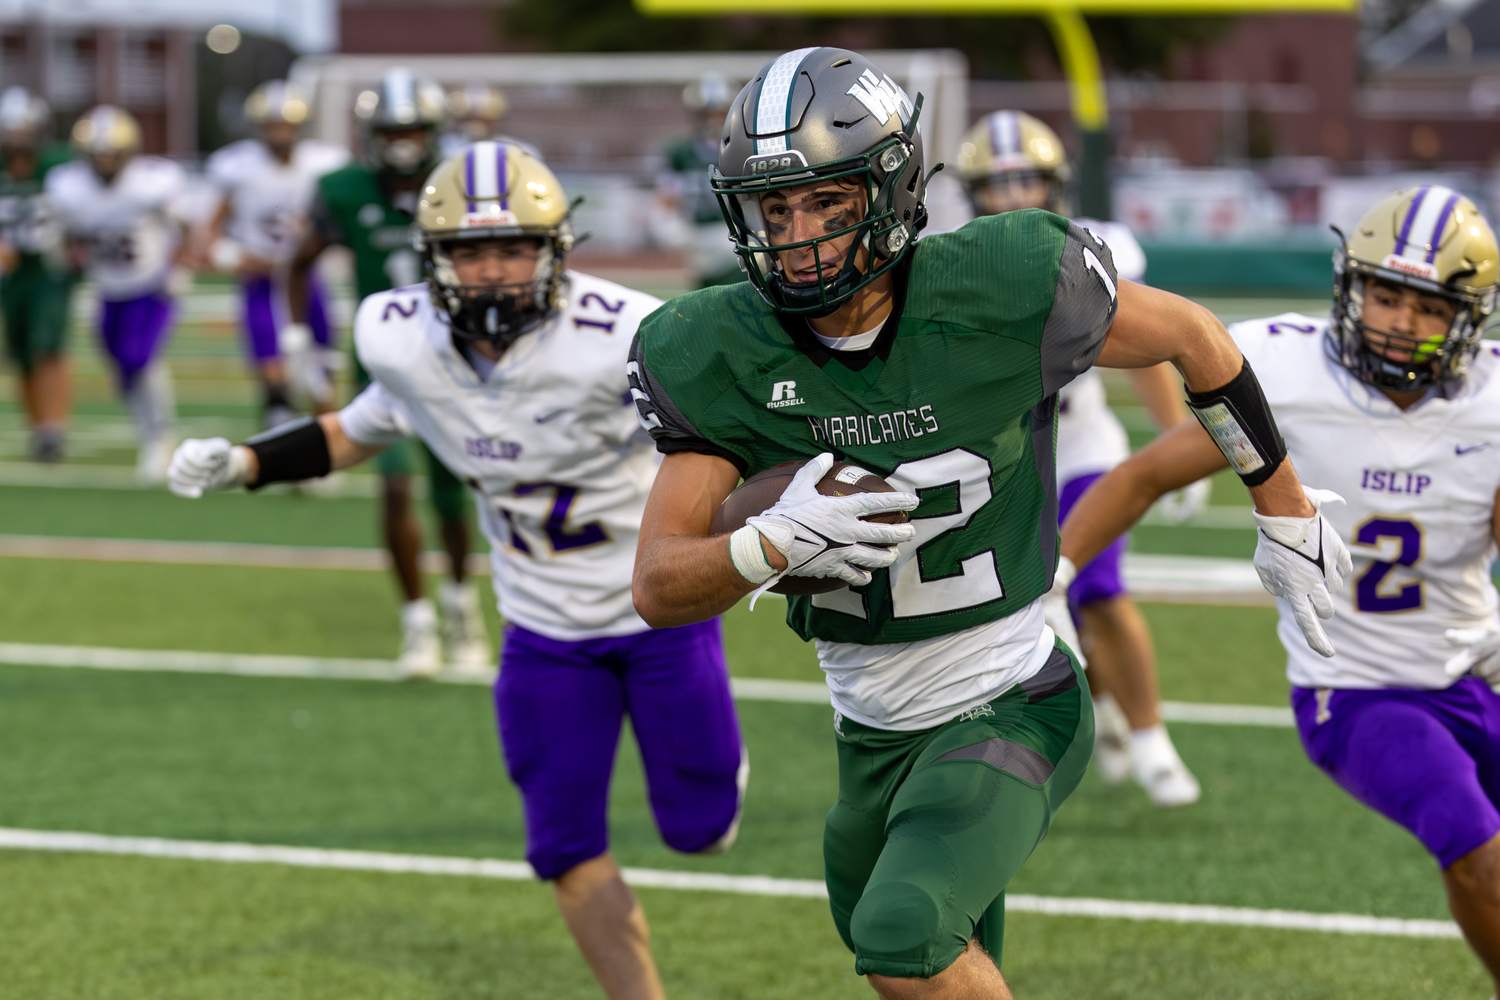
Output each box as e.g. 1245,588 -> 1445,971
0,828 -> 1460,939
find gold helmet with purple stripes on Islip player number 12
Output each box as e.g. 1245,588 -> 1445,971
417,142 -> 573,349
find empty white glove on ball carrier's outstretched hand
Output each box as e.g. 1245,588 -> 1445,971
1256,486 -> 1355,657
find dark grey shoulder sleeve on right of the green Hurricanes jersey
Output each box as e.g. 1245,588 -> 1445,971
1041,223 -> 1119,396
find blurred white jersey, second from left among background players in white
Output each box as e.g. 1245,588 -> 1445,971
207,139 -> 350,264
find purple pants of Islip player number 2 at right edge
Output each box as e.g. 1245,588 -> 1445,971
1292,678 -> 1500,868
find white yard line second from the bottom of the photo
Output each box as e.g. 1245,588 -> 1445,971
0,642 -> 1293,729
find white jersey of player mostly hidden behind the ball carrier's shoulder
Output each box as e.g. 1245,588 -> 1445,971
1058,219 -> 1146,484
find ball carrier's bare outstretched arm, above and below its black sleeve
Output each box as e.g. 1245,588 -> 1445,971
1098,282 -> 1314,517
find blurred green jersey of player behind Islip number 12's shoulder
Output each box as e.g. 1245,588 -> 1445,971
312,163 -> 422,300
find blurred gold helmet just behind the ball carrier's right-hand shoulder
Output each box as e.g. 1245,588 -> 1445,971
959,111 -> 1073,216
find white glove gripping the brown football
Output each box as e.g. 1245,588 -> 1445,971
746,451 -> 920,586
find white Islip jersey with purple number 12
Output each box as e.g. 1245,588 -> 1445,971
348,271 -> 662,640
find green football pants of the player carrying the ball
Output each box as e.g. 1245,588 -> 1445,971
824,642 -> 1094,979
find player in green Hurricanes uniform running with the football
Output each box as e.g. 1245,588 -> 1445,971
630,48 -> 1349,999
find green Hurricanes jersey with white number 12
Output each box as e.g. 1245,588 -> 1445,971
630,210 -> 1116,645
